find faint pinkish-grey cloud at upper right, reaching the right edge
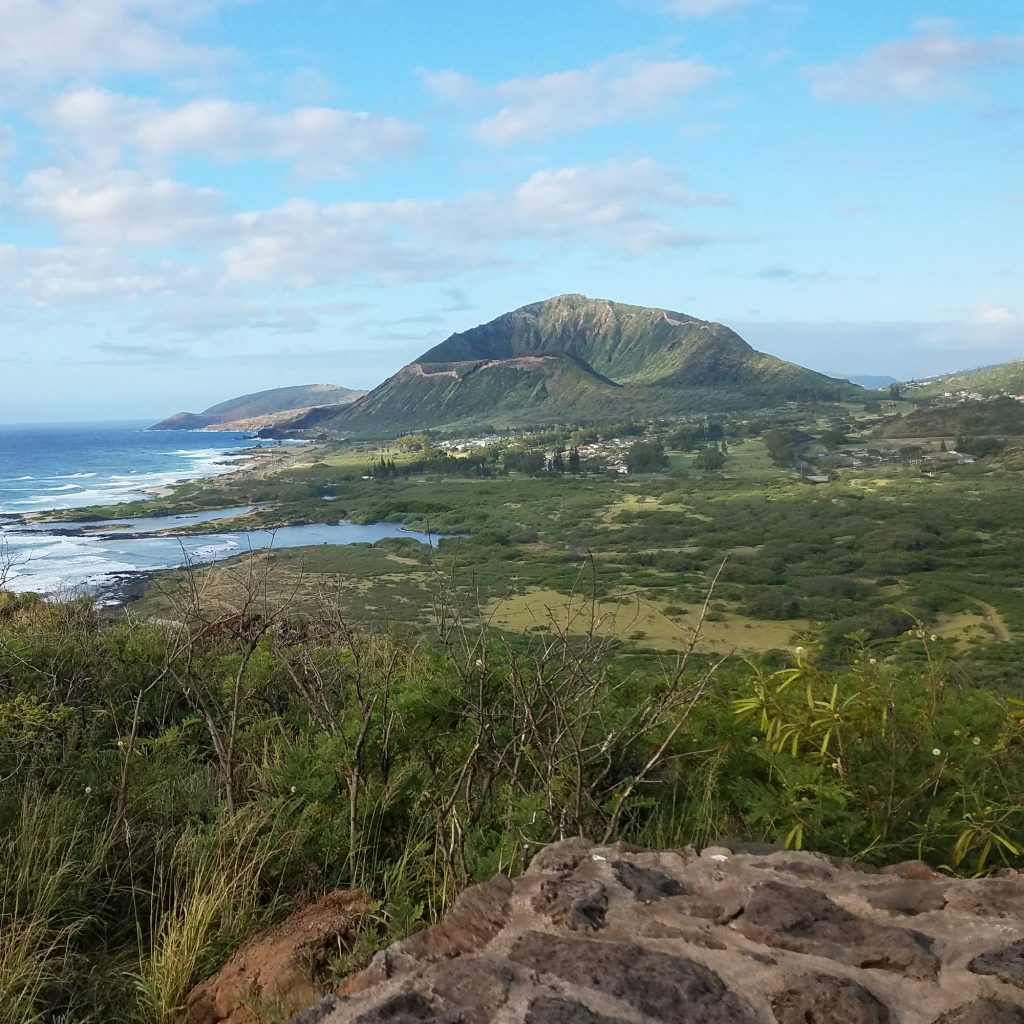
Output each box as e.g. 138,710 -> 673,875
809,20 -> 1024,102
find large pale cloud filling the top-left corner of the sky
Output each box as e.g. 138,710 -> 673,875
0,0 -> 230,88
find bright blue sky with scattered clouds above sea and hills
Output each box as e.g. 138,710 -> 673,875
0,0 -> 1024,421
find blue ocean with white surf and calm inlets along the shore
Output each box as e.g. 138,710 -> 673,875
0,415 -> 434,603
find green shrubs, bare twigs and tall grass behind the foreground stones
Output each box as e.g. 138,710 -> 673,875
0,575 -> 1024,1024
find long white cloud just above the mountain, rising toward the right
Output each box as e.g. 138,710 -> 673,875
222,160 -> 725,287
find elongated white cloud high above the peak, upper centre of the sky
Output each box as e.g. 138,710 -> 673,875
422,54 -> 718,145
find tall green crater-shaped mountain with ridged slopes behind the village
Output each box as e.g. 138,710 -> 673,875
292,295 -> 862,435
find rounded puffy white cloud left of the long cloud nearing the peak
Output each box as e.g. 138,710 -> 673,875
22,167 -> 230,246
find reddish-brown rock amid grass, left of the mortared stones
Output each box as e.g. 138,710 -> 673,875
178,892 -> 370,1024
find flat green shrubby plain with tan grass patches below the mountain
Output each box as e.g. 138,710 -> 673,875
90,415 -> 1024,675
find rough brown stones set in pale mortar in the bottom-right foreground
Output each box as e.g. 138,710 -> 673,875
297,840 -> 1024,1024
